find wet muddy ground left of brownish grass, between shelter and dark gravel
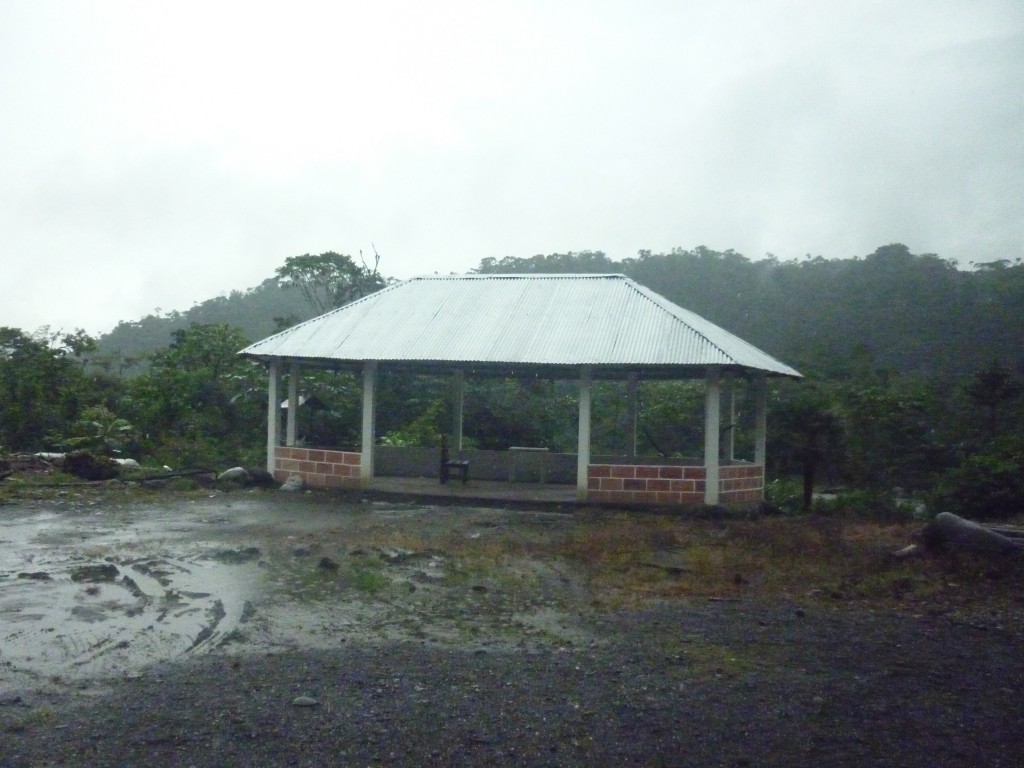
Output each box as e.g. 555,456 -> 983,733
0,492 -> 584,691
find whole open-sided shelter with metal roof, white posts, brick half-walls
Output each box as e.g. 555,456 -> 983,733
241,274 -> 800,506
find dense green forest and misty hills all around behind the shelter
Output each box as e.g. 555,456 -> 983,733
0,245 -> 1024,517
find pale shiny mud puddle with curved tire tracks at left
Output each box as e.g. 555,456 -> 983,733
0,510 -> 263,682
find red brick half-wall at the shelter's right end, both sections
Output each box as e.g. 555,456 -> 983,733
587,464 -> 765,507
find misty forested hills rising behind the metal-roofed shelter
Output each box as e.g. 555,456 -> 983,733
94,245 -> 1024,376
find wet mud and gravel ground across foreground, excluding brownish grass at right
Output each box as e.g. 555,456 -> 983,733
0,489 -> 1024,767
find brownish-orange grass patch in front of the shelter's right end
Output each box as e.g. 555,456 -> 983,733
550,514 -> 937,606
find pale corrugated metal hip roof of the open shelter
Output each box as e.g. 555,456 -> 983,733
241,274 -> 800,377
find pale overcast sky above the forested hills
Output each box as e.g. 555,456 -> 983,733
0,0 -> 1024,334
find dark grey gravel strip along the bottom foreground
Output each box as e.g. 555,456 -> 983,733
0,601 -> 1024,768
